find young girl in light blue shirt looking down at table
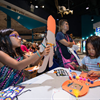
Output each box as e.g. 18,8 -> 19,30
82,36 -> 100,76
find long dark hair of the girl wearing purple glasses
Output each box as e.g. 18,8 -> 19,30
0,29 -> 24,57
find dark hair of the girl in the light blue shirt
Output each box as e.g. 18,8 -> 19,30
85,36 -> 100,58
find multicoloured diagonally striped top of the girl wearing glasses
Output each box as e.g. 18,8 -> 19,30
0,57 -> 25,90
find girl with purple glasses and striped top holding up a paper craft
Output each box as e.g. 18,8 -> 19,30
0,29 -> 50,90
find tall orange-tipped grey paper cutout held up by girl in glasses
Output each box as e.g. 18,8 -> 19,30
38,15 -> 56,73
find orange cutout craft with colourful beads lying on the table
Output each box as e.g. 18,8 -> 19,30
62,72 -> 100,98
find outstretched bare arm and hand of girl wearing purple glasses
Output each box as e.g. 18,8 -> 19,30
0,46 -> 50,70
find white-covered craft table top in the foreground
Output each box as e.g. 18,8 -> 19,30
18,67 -> 100,100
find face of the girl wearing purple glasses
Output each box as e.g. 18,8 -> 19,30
9,31 -> 21,48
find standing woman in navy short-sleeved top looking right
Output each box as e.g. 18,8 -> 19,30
56,19 -> 77,67
